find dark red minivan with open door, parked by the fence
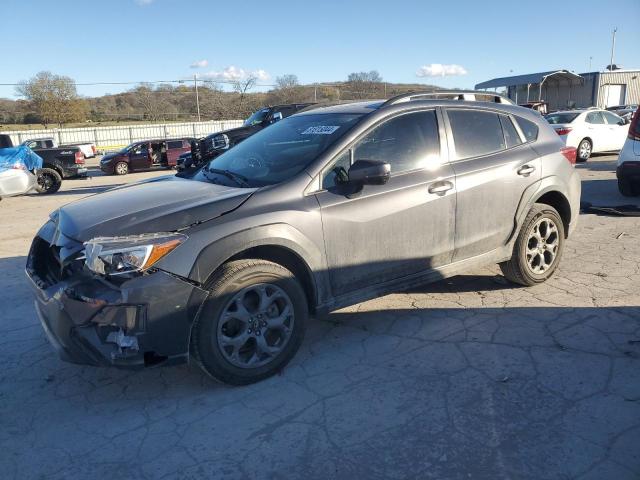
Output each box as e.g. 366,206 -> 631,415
100,137 -> 192,175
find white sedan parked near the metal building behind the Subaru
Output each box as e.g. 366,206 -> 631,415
544,108 -> 629,162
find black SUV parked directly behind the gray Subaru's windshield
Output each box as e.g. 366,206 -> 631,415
189,103 -> 313,168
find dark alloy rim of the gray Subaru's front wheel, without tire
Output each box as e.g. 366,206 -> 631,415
217,283 -> 295,368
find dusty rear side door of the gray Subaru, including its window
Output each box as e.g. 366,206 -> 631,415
445,108 -> 542,261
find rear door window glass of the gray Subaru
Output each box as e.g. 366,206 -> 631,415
447,110 -> 507,159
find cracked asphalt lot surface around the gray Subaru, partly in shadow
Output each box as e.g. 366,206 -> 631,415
0,156 -> 640,480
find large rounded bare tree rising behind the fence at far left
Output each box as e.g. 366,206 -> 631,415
16,72 -> 87,126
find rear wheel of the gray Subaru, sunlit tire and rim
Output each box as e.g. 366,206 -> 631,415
500,203 -> 565,287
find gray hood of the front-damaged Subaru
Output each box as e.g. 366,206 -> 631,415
58,176 -> 256,242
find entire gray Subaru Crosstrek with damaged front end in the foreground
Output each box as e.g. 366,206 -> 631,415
26,94 -> 580,384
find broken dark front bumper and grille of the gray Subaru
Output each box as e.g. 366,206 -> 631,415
26,229 -> 207,367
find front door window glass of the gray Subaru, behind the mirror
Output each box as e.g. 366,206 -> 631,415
353,110 -> 440,175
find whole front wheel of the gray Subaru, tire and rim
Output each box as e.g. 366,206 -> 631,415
190,260 -> 309,385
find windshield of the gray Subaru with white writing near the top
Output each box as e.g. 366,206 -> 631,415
194,113 -> 362,187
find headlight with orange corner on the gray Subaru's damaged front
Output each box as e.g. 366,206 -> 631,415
84,233 -> 187,275
